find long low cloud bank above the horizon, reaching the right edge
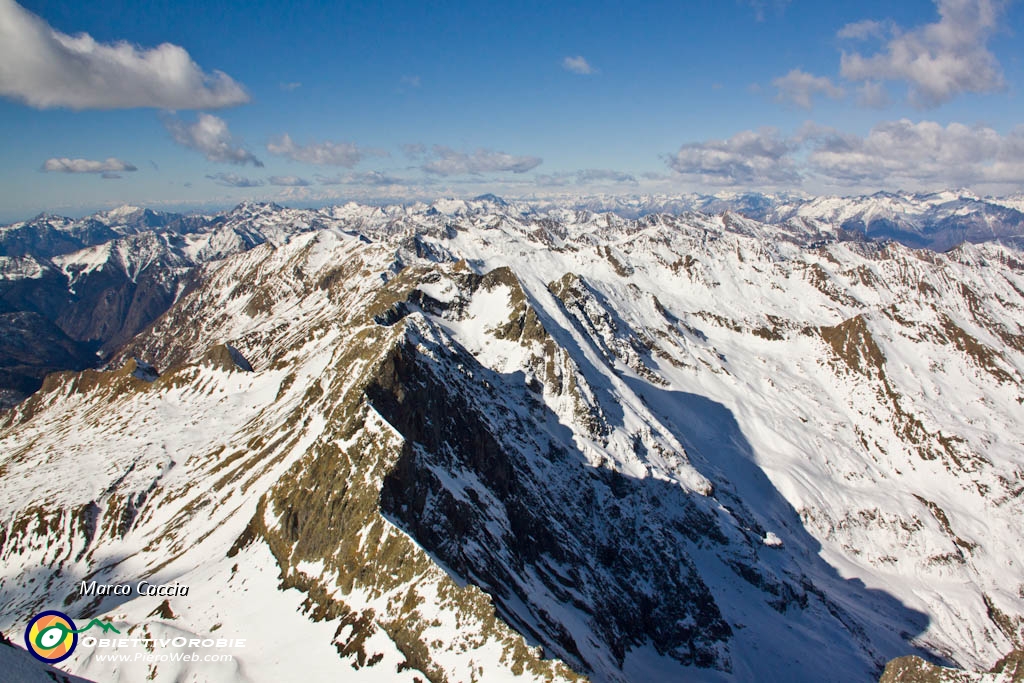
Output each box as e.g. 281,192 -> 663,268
668,119 -> 1024,189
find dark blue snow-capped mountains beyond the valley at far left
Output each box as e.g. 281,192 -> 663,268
0,204 -> 327,410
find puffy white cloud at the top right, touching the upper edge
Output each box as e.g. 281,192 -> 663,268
840,0 -> 1006,106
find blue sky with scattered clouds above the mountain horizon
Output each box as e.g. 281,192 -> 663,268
0,0 -> 1024,220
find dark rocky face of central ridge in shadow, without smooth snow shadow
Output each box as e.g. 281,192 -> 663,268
367,333 -> 732,678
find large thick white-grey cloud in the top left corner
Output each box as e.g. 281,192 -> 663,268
0,0 -> 249,110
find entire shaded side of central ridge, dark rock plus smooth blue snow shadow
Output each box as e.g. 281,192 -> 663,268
367,327 -> 934,681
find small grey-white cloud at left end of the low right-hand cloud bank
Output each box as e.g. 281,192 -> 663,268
668,128 -> 801,186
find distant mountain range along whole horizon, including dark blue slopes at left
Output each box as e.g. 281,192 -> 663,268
0,190 -> 1024,408
